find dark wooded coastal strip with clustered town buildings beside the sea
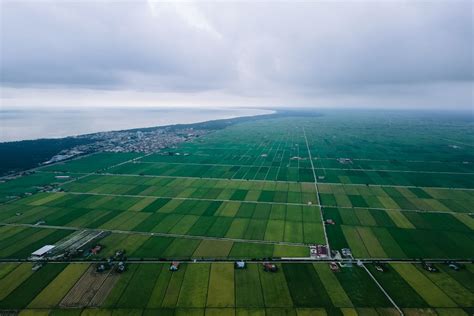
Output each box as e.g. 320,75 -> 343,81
0,111 -> 279,179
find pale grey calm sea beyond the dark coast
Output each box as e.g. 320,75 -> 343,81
0,108 -> 273,142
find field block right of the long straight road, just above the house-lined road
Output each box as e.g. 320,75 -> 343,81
323,208 -> 474,258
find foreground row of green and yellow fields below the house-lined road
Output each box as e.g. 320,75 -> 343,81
0,263 -> 474,315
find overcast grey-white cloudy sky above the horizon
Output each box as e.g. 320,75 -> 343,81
0,0 -> 474,111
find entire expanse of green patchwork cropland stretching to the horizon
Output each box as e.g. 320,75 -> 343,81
0,110 -> 474,315
